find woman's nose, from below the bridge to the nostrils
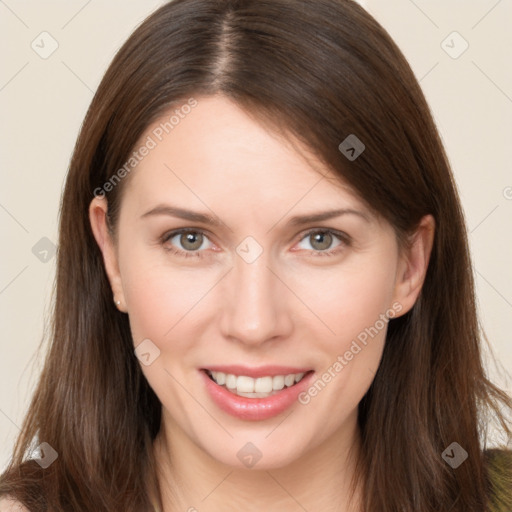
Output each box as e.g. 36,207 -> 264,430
221,251 -> 293,346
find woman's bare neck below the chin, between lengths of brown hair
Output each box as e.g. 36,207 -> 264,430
154,413 -> 361,512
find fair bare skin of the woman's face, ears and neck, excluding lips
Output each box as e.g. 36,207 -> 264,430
89,96 -> 434,512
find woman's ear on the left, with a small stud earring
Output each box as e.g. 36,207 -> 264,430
89,196 -> 127,313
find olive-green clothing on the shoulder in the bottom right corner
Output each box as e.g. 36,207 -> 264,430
484,448 -> 512,511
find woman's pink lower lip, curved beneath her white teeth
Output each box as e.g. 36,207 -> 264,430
200,370 -> 314,421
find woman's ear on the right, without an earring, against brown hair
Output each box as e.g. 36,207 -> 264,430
394,215 -> 435,316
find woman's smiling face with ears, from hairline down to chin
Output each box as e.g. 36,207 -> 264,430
91,97 -> 428,468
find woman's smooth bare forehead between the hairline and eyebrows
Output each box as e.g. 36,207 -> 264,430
123,96 -> 368,214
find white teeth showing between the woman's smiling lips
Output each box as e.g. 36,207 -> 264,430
203,370 -> 313,398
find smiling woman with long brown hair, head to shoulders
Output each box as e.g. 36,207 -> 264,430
0,0 -> 512,512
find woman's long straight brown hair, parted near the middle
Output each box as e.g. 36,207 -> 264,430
0,0 -> 512,512
